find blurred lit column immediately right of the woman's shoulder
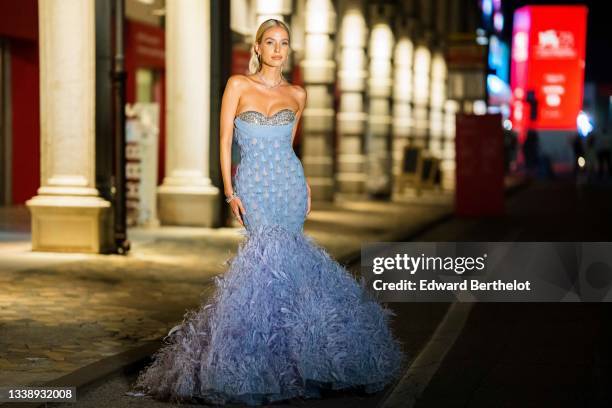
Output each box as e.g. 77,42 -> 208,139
302,0 -> 336,201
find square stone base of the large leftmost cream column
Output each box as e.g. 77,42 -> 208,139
26,195 -> 114,253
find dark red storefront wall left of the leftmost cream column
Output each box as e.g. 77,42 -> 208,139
0,0 -> 40,205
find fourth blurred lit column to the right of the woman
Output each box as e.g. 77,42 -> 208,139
392,16 -> 414,196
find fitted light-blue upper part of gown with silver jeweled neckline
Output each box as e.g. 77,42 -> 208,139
234,109 -> 308,231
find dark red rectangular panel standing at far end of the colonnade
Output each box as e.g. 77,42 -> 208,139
455,114 -> 504,216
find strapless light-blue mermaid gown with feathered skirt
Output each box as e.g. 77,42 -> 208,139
136,109 -> 406,405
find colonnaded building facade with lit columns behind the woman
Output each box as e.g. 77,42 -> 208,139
0,0 -> 486,252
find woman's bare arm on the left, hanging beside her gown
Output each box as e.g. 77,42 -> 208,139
219,75 -> 242,197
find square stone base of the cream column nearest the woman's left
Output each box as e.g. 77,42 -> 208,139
157,185 -> 221,227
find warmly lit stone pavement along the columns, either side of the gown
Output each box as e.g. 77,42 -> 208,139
0,186 -> 453,386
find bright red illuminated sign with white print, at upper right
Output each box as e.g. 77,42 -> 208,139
511,5 -> 588,139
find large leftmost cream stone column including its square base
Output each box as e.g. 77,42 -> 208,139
26,0 -> 114,253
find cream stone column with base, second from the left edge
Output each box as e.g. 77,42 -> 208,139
158,0 -> 220,227
